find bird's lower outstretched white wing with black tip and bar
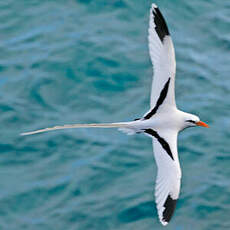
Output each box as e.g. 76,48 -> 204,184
145,129 -> 181,225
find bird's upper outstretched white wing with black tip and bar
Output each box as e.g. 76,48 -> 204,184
148,4 -> 176,112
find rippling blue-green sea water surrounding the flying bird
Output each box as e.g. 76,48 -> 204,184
0,0 -> 230,230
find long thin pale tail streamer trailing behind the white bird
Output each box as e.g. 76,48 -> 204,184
20,122 -> 130,136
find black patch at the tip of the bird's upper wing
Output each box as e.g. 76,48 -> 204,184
152,4 -> 170,43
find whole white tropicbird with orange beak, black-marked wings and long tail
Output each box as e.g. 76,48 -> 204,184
21,4 -> 209,225
